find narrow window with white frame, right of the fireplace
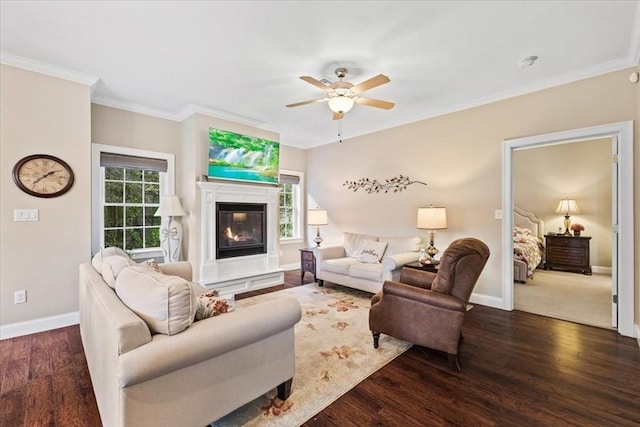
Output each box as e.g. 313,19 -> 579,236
280,170 -> 304,241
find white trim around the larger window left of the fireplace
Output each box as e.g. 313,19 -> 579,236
91,143 -> 176,258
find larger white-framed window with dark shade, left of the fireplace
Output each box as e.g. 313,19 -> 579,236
92,144 -> 173,257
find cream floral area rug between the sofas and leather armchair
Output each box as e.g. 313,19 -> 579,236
212,282 -> 411,427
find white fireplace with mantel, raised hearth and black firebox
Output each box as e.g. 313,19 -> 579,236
197,181 -> 284,295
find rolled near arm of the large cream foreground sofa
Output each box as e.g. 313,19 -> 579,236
118,297 -> 301,387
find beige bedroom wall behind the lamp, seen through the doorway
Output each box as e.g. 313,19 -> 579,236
513,139 -> 612,268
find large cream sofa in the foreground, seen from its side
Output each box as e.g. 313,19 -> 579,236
80,249 -> 301,427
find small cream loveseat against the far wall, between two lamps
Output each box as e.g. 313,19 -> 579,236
314,233 -> 422,293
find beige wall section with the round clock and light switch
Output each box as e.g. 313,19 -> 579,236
0,65 -> 91,325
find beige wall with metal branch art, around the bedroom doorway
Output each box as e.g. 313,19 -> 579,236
307,69 -> 640,314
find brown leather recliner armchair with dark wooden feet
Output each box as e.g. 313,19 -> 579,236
369,238 -> 489,371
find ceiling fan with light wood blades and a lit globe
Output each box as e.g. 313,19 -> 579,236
287,68 -> 395,120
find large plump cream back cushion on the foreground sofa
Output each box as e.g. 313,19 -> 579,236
116,265 -> 197,335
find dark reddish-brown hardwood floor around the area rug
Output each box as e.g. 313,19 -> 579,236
0,271 -> 640,427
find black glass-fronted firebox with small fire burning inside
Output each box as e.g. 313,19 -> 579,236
216,202 -> 267,259
